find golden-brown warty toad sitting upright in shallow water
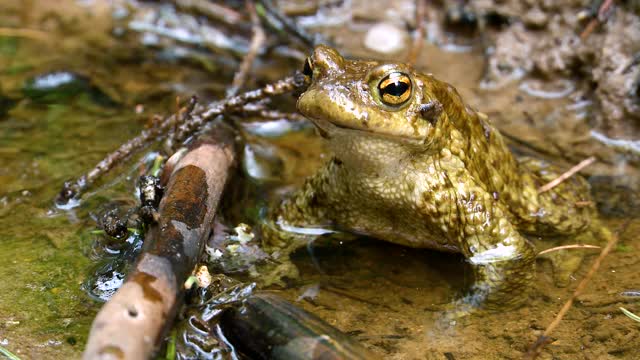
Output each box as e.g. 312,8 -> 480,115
263,46 -> 610,307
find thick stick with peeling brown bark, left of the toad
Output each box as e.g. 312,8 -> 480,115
83,123 -> 235,360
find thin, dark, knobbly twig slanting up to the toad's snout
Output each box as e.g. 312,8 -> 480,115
55,74 -> 305,205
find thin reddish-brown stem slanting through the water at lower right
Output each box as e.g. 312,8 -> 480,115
524,229 -> 618,360
